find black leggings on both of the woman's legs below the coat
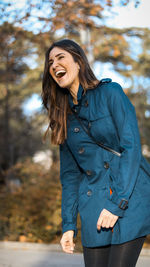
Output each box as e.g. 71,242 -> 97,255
83,236 -> 146,267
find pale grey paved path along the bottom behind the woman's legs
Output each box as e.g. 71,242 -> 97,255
0,244 -> 150,267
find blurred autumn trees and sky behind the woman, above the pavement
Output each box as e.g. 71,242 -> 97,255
0,0 -> 150,249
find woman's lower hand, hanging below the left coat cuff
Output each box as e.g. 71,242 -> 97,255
60,230 -> 75,253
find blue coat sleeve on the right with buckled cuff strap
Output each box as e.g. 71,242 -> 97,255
105,83 -> 142,217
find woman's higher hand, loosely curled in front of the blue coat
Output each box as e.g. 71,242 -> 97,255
97,209 -> 118,231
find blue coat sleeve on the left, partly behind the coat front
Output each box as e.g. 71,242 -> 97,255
59,141 -> 81,237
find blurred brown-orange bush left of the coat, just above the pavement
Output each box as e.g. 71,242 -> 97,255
0,158 -> 61,245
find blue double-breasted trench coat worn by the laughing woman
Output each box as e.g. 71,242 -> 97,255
59,78 -> 150,247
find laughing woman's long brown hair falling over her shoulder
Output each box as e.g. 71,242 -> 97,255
42,39 -> 99,145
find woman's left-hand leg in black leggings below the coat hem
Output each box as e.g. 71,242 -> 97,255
83,245 -> 110,267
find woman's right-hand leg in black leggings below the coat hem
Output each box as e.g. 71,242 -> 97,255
108,236 -> 146,267
